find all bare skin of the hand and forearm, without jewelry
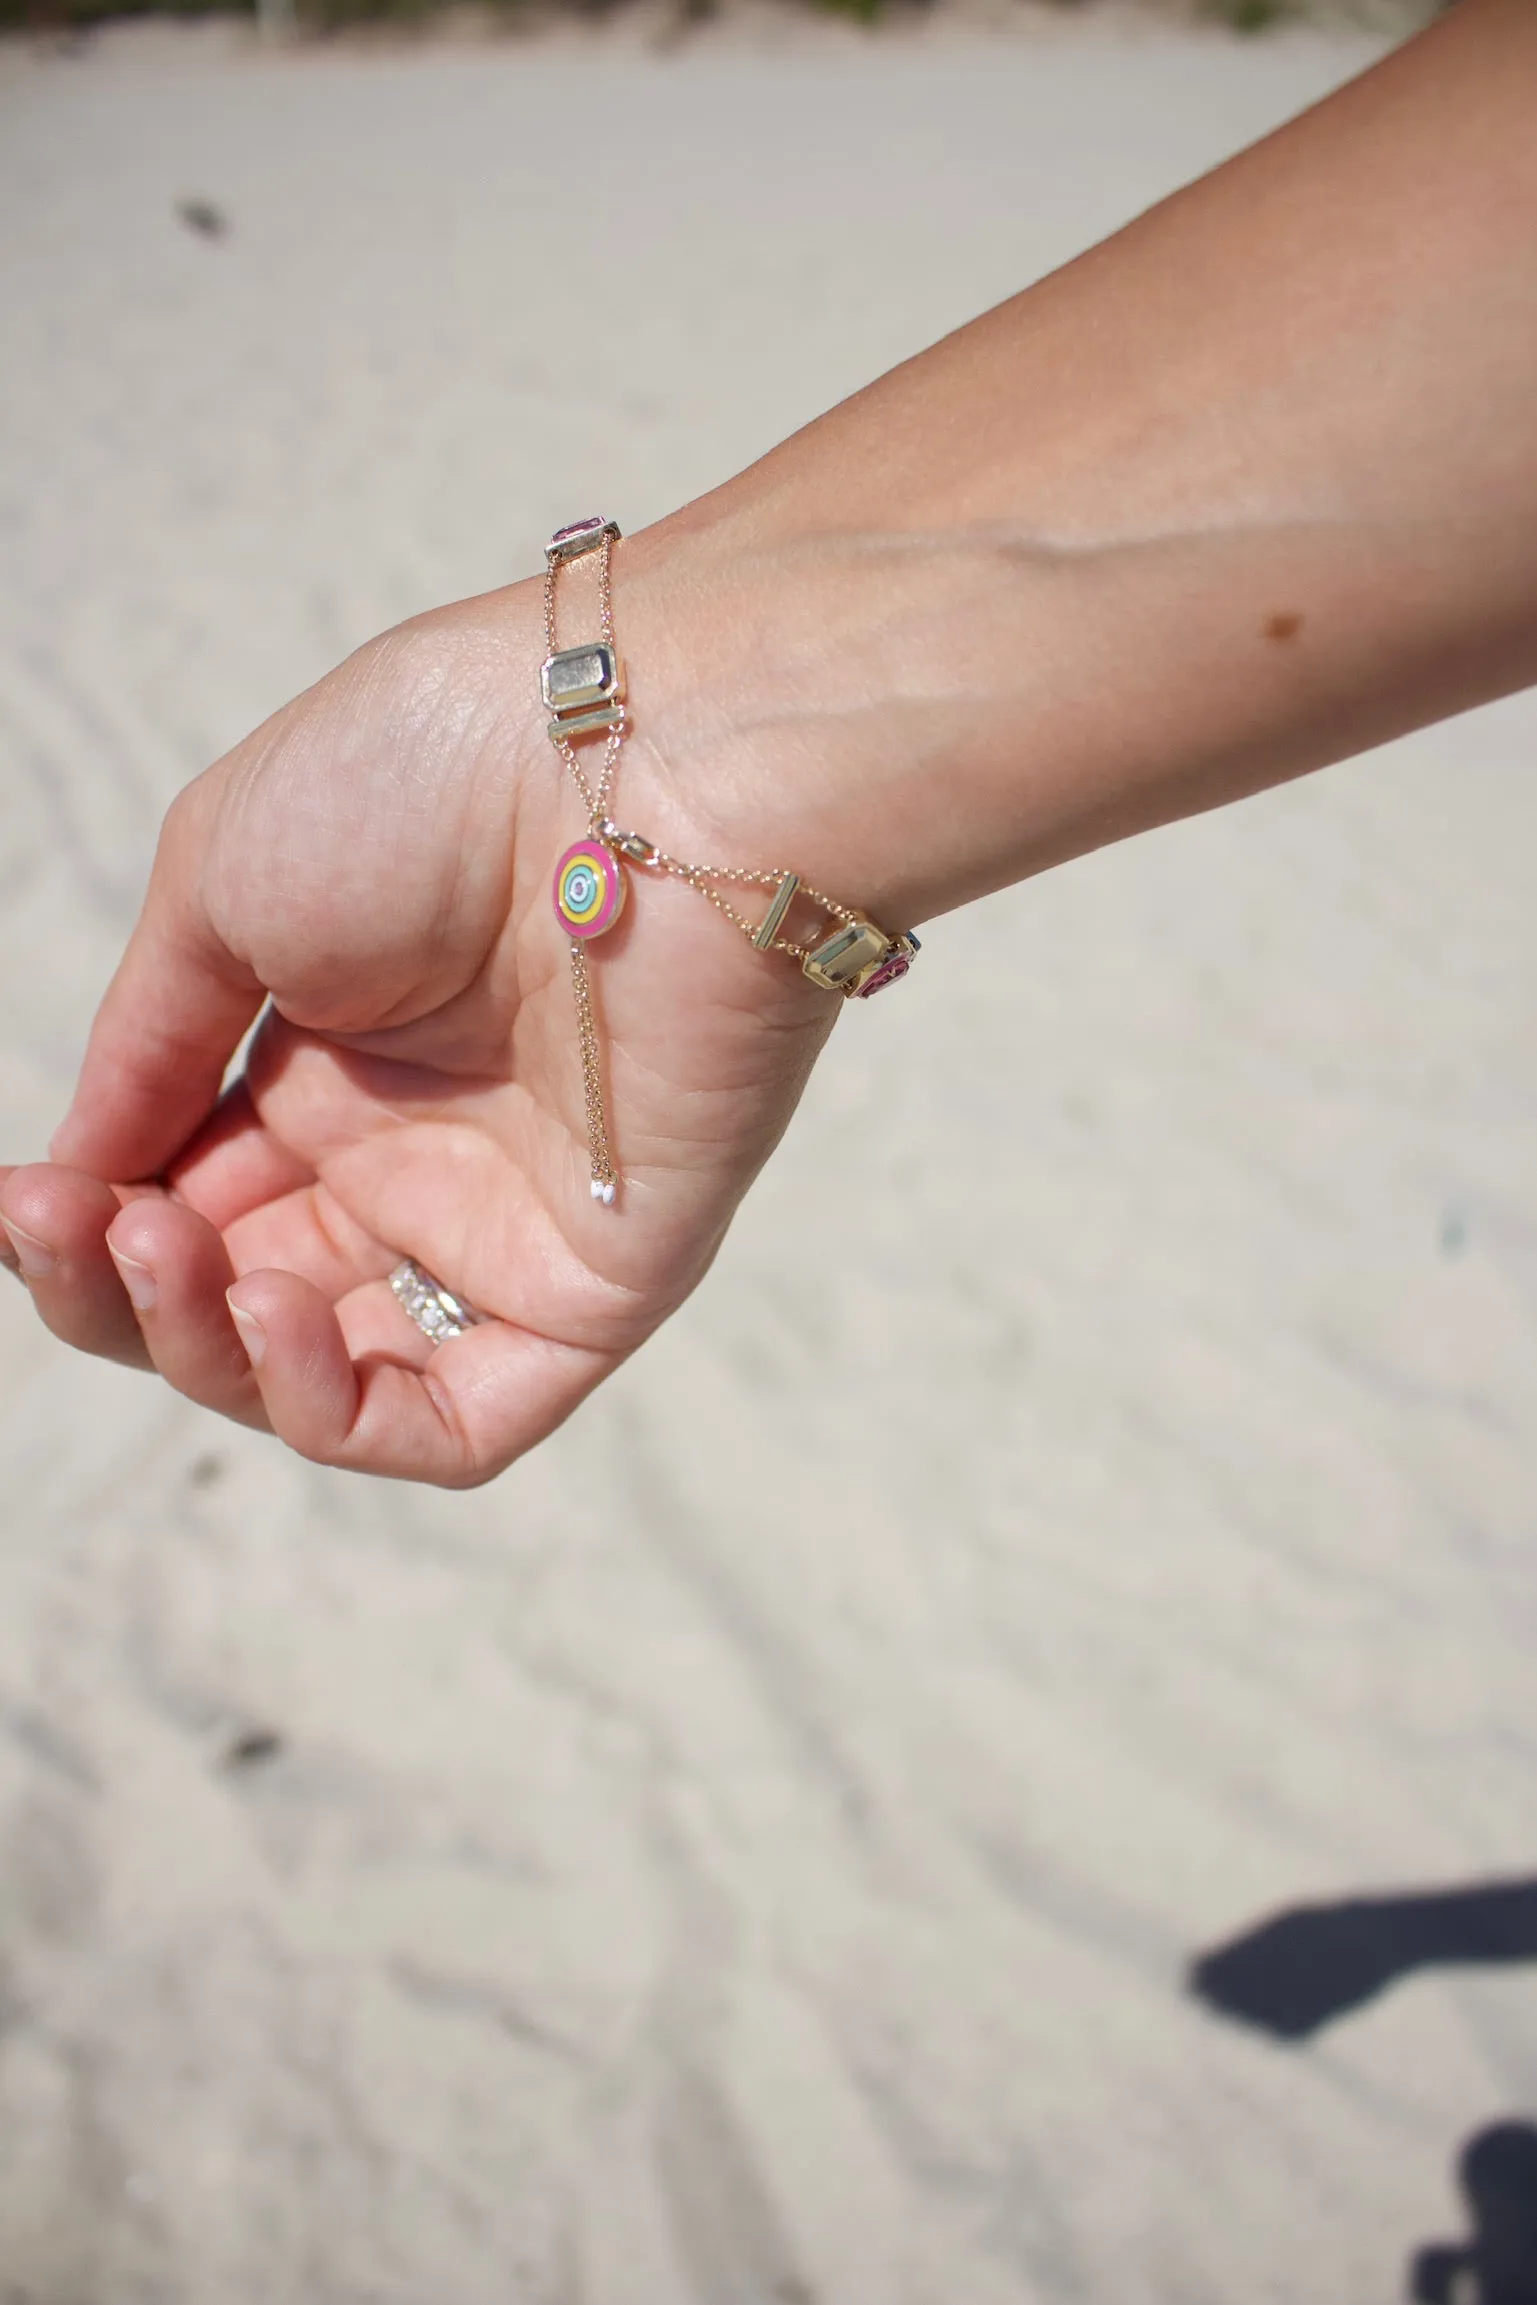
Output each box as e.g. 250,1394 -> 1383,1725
0,0 -> 1537,1487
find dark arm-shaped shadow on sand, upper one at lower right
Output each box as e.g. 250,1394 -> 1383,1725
1189,1881 -> 1537,2040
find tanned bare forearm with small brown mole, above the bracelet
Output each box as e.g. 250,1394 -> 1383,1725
629,0 -> 1537,920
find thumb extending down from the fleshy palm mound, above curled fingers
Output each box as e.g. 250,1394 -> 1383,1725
51,781 -> 263,1176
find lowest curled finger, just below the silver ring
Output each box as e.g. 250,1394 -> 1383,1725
230,1272 -> 618,1489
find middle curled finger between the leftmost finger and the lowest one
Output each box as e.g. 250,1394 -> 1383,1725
106,1199 -> 267,1427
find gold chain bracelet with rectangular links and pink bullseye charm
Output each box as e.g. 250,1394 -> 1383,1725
539,514 -> 919,1208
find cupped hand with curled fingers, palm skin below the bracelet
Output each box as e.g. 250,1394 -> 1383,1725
0,567 -> 839,1487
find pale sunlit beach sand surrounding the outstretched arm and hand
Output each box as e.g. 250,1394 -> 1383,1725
0,14 -> 1537,2305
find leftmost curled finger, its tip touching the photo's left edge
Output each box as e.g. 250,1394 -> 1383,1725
0,1162 -> 150,1369
